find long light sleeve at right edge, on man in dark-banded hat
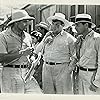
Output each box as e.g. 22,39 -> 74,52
93,37 -> 100,88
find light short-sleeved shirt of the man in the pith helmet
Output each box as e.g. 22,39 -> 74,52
0,28 -> 32,65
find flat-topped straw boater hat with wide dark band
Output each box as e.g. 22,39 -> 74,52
75,14 -> 96,28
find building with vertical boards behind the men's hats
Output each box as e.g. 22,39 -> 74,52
0,4 -> 100,32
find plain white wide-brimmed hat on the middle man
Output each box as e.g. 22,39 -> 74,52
47,13 -> 70,27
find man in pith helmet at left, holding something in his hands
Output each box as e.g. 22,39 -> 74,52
0,10 -> 41,93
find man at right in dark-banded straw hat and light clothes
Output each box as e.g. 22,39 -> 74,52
75,14 -> 100,95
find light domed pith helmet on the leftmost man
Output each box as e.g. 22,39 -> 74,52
7,10 -> 35,26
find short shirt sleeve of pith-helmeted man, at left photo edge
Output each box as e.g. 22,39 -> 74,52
0,34 -> 7,53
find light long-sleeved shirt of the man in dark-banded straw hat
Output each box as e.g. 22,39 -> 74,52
78,31 -> 100,87
